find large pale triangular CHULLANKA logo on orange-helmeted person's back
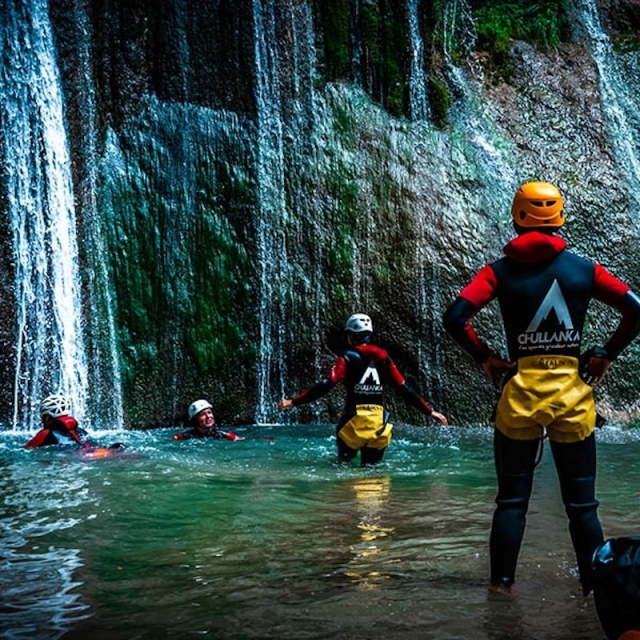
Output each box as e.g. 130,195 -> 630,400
518,280 -> 580,350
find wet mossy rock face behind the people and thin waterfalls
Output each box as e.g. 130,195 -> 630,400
0,0 -> 640,426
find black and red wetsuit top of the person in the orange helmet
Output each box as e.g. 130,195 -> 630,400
445,231 -> 639,362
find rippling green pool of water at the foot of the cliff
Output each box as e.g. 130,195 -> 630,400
0,425 -> 640,640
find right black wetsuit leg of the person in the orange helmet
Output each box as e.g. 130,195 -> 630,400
551,433 -> 604,589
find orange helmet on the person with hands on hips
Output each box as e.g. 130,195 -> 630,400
511,182 -> 564,229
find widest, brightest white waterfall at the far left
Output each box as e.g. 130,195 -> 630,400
0,0 -> 87,427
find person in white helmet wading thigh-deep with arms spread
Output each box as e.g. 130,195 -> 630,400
278,313 -> 447,466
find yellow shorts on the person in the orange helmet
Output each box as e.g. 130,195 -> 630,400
495,355 -> 596,442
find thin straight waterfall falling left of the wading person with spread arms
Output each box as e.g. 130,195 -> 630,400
253,0 -> 287,423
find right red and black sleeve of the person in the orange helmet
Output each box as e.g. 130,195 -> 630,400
593,265 -> 640,360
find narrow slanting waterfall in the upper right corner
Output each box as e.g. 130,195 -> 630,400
574,0 -> 640,212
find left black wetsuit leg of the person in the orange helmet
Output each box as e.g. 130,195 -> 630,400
489,429 -> 540,585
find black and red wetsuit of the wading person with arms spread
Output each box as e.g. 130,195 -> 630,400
292,344 -> 433,465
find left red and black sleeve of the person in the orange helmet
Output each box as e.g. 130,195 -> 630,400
443,266 -> 498,363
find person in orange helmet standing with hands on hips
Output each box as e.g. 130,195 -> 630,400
444,182 -> 640,594
